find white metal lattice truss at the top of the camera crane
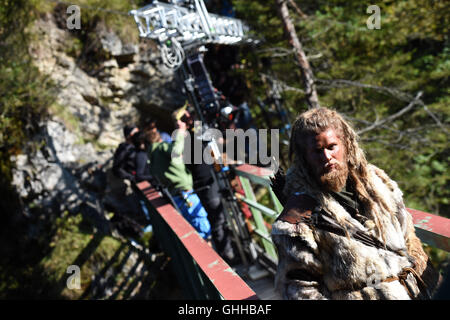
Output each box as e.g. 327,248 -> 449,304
129,0 -> 253,69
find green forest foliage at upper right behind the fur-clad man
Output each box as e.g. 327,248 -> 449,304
233,0 -> 450,217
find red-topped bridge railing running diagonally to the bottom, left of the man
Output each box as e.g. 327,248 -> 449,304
135,181 -> 258,300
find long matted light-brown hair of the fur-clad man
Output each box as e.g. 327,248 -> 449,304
284,107 -> 390,240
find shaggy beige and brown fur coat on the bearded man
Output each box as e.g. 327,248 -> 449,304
271,165 -> 439,300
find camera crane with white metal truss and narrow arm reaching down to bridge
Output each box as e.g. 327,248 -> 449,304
130,0 -> 276,271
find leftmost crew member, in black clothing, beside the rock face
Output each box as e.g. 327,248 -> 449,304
112,125 -> 139,182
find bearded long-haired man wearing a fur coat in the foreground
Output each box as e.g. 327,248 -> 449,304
272,108 -> 439,300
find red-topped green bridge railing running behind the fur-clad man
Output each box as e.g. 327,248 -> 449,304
234,164 -> 450,252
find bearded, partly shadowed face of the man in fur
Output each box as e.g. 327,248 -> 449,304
304,128 -> 348,191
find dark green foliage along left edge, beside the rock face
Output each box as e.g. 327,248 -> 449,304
0,0 -> 53,214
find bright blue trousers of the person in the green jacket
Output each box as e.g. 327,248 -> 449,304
173,191 -> 211,239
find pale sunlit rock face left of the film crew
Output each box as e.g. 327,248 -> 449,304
13,14 -> 185,236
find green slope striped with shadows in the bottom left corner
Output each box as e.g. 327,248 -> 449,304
0,212 -> 126,299
